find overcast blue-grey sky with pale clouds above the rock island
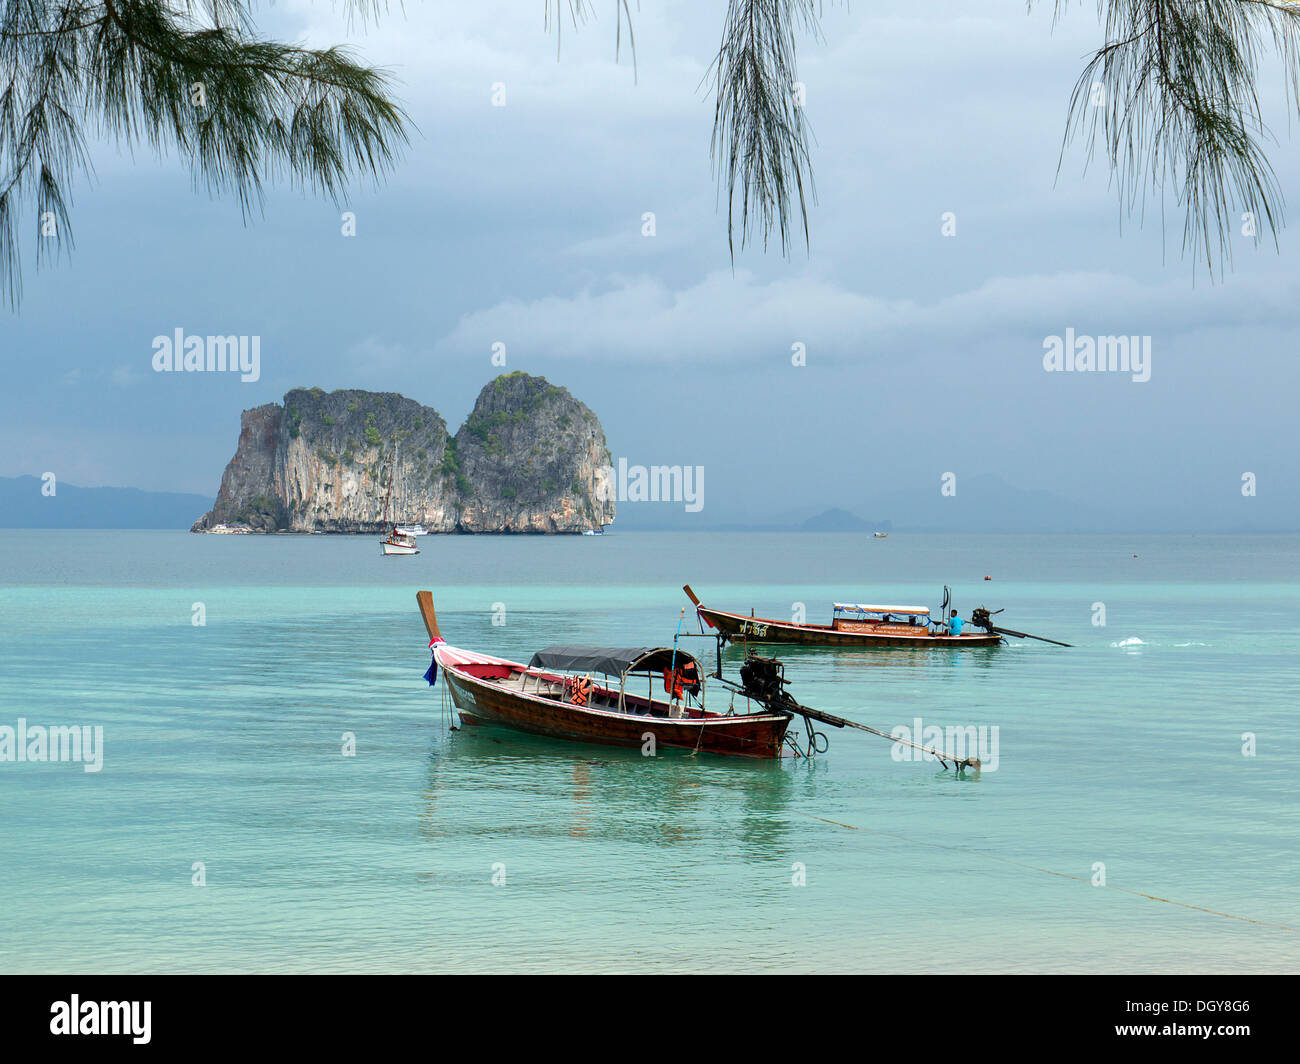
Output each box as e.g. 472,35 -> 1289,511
0,0 -> 1300,527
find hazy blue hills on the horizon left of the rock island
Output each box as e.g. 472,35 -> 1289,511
0,476 -> 212,528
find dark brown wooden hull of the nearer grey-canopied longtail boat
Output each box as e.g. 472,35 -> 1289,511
434,646 -> 790,758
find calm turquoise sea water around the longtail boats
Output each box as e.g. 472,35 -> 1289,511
0,531 -> 1300,973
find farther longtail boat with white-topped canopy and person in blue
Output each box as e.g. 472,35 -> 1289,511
683,584 -> 1002,648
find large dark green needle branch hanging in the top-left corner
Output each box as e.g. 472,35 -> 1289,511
0,0 -> 407,304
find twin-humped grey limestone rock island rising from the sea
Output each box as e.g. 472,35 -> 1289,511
192,373 -> 614,532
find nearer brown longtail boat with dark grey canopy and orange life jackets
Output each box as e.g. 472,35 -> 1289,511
416,591 -> 792,757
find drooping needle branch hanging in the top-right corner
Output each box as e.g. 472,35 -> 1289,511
1030,0 -> 1300,273
